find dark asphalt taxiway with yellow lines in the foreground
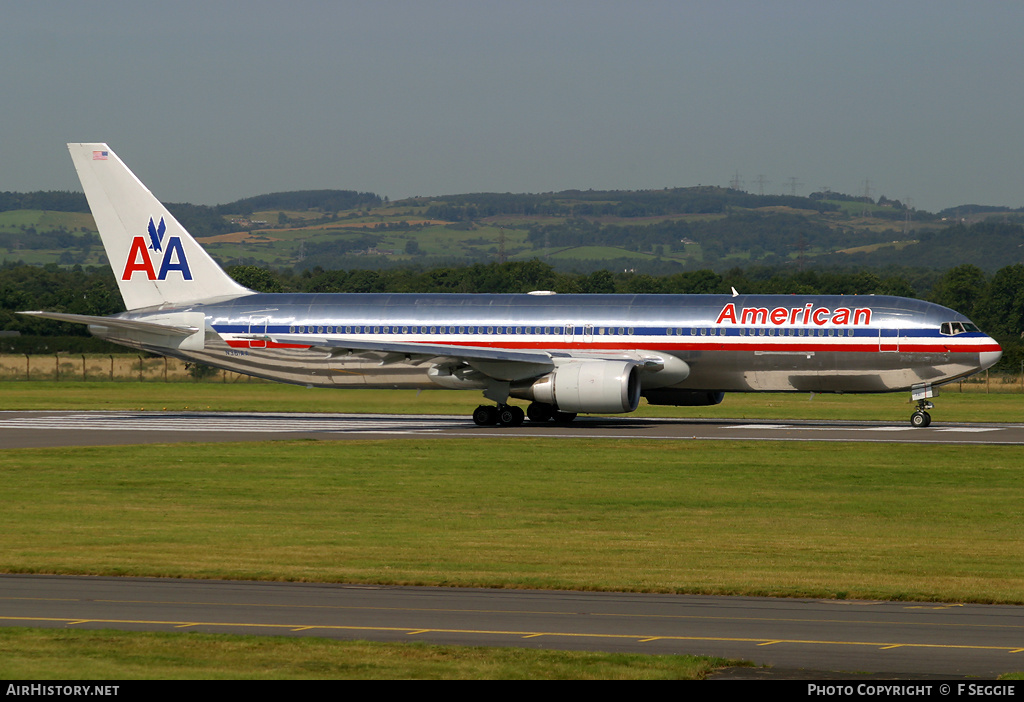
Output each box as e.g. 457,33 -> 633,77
0,575 -> 1024,677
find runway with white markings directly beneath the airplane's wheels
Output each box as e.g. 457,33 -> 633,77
0,411 -> 1024,448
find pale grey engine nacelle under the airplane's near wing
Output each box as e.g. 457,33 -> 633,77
511,360 -> 640,414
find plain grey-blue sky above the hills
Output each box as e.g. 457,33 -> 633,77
0,0 -> 1024,212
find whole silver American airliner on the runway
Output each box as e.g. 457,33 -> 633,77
23,143 -> 1002,427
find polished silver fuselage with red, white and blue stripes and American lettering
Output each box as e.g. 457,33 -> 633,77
90,294 -> 1000,393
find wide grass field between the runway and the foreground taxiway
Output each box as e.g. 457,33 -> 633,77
0,438 -> 1024,603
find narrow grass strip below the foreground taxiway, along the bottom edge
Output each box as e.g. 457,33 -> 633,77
0,628 -> 737,679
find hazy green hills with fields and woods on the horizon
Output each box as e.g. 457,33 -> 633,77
8,186 -> 1024,274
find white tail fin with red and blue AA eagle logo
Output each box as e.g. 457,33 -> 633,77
68,143 -> 252,310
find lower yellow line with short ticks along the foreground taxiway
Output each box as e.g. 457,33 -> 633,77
0,616 -> 1024,654
